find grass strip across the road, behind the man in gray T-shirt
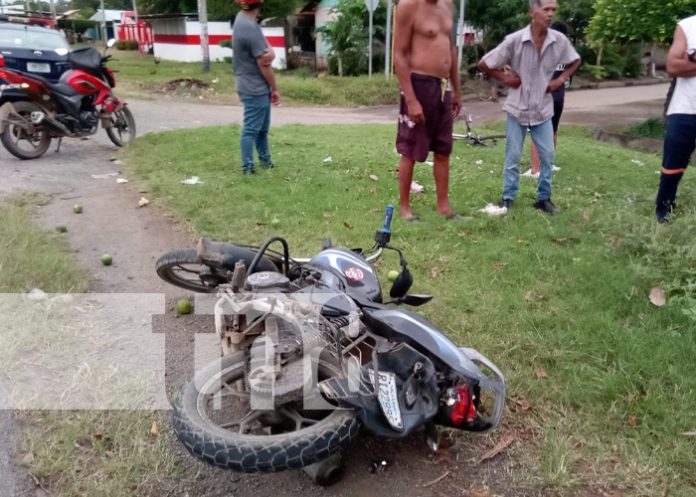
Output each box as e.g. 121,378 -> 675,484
110,51 -> 399,107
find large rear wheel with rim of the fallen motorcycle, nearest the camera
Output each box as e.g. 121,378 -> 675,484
173,352 -> 360,473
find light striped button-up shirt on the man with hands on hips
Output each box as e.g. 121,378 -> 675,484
483,25 -> 580,126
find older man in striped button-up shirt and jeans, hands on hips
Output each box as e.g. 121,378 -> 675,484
478,0 -> 580,214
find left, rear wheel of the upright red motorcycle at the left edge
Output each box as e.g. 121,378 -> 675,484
0,101 -> 51,160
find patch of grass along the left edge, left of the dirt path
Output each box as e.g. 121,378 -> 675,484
0,194 -> 179,497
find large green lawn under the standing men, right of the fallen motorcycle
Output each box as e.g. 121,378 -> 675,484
126,121 -> 696,497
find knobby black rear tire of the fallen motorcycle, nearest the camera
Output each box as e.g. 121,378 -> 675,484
173,353 -> 360,473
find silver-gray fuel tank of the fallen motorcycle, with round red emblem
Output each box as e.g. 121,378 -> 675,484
310,248 -> 382,302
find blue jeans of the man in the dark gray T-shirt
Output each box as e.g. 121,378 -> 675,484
239,93 -> 272,172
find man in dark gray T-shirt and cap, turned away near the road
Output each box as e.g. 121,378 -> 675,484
232,0 -> 280,174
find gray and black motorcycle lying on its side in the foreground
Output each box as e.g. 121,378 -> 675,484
157,206 -> 505,484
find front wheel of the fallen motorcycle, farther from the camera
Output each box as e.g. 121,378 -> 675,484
155,249 -> 227,293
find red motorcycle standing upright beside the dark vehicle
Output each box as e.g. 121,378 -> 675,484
0,40 -> 135,159
